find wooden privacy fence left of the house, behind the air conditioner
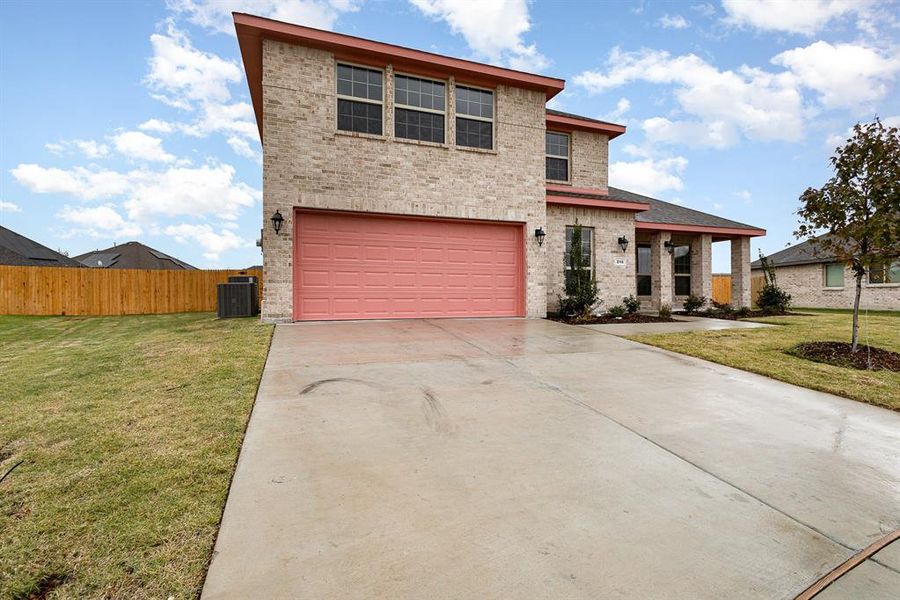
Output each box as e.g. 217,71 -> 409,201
0,265 -> 262,315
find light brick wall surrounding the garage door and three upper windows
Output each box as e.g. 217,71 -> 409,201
262,40 -> 547,321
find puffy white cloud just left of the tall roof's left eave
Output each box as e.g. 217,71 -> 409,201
144,22 -> 243,110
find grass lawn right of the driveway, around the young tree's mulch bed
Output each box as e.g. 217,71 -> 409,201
629,309 -> 900,410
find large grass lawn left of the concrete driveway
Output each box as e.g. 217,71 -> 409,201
0,313 -> 272,598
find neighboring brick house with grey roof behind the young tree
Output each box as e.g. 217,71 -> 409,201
751,237 -> 900,310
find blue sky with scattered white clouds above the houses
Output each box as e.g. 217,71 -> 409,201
0,0 -> 900,272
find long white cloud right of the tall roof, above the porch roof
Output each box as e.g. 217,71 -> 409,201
574,48 -> 804,141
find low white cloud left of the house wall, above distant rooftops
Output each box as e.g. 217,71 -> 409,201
124,164 -> 261,223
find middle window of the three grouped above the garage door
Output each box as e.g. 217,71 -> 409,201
394,75 -> 447,144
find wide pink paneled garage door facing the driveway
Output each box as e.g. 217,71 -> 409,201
294,211 -> 525,321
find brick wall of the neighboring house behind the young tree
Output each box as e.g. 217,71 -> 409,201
753,264 -> 900,310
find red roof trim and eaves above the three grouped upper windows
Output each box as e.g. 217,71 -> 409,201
232,12 -> 566,137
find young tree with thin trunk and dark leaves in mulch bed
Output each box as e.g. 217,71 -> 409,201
794,118 -> 900,352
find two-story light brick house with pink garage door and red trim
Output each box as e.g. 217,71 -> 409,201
234,13 -> 765,321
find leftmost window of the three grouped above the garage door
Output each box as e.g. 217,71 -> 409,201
337,64 -> 384,135
